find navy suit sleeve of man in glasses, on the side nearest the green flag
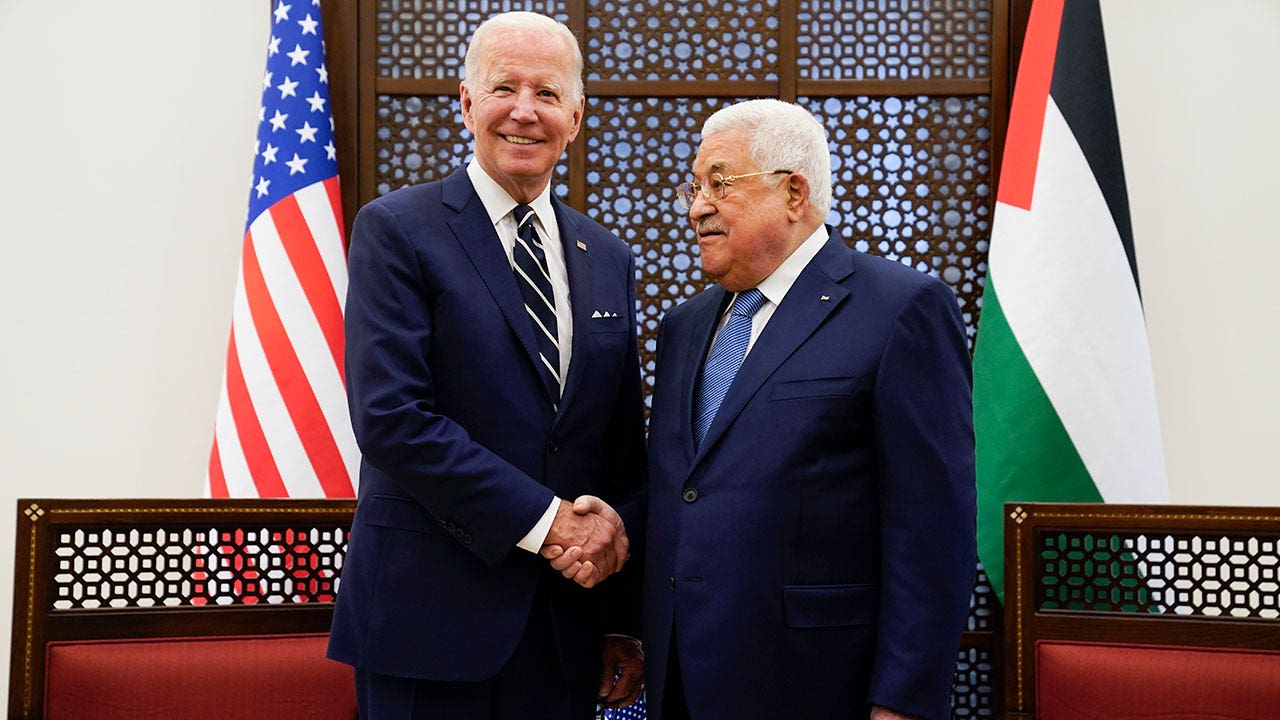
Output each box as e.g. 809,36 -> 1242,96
870,279 -> 977,717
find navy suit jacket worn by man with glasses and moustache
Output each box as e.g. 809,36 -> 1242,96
644,228 -> 975,720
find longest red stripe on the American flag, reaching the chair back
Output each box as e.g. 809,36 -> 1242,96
241,233 -> 353,497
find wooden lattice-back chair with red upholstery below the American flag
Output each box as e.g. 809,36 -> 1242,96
9,500 -> 356,720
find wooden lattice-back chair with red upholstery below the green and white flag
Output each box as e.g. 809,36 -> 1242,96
1005,503 -> 1280,720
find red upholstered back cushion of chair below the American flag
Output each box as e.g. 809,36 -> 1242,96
45,633 -> 356,720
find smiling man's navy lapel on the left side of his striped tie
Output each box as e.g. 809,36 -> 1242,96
443,170 -> 545,389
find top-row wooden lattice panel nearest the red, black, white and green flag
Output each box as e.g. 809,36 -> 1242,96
796,0 -> 992,79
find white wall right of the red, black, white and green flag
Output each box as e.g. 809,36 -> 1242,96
1102,0 -> 1280,505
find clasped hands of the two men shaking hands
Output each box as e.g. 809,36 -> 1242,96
541,495 -> 630,588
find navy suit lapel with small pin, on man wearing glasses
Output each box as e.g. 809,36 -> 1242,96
690,228 -> 854,461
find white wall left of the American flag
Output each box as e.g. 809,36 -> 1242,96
0,0 -> 270,679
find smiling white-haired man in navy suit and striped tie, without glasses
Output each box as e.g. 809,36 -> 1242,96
329,13 -> 645,720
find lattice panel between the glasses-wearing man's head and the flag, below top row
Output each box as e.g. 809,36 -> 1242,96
799,96 -> 995,346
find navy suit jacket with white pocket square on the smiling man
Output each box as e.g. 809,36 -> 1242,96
329,170 -> 644,683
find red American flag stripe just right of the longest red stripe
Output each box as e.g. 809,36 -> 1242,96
268,195 -> 346,382
